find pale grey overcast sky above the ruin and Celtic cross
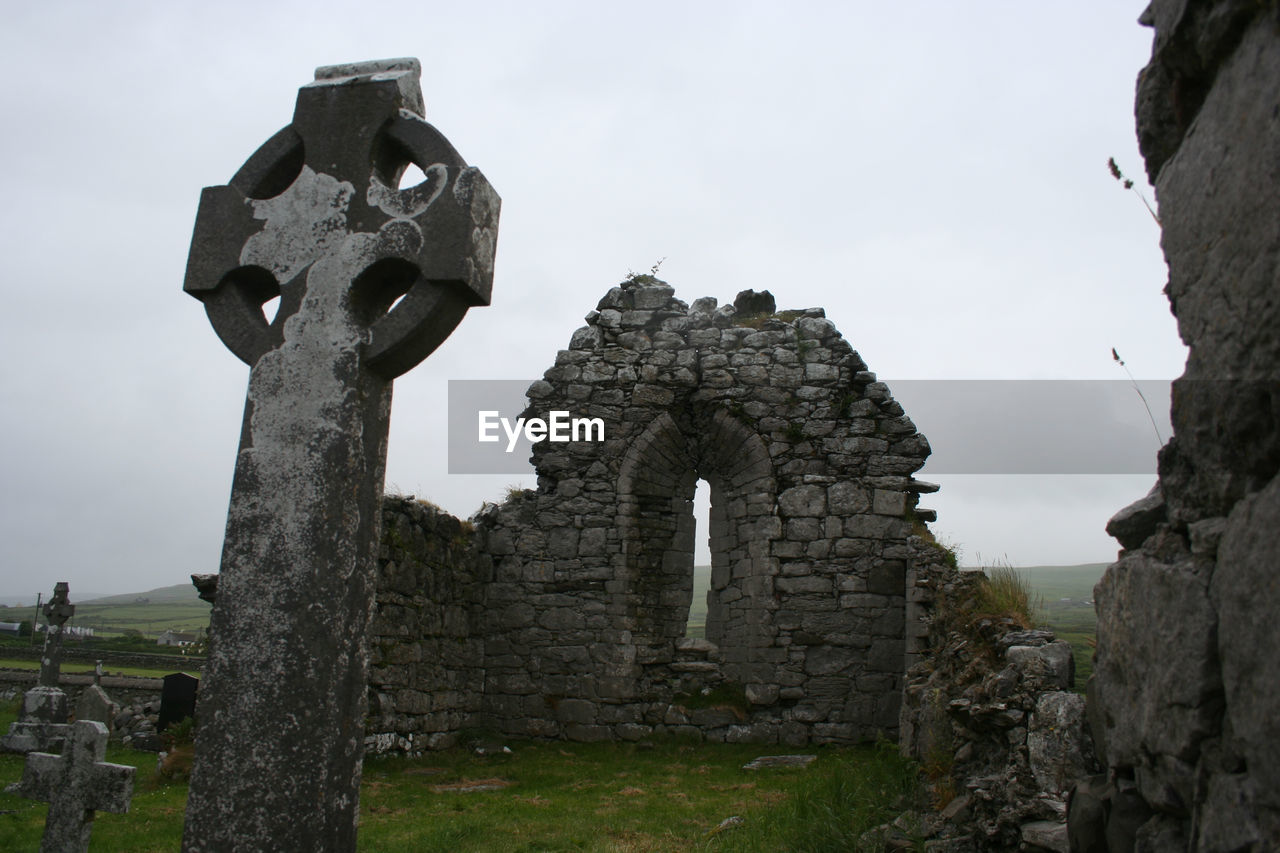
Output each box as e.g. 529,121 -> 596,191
0,0 -> 1185,601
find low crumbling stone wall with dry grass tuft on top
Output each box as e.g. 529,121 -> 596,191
896,538 -> 1098,853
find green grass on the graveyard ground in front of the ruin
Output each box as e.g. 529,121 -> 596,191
0,707 -> 915,853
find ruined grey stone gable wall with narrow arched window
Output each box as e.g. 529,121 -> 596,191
369,277 -> 936,752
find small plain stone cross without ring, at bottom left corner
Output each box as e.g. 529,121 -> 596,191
13,720 -> 134,853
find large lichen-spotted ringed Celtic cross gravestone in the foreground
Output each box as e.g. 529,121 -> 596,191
183,59 -> 499,853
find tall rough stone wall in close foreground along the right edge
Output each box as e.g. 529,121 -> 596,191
1089,0 -> 1280,852
